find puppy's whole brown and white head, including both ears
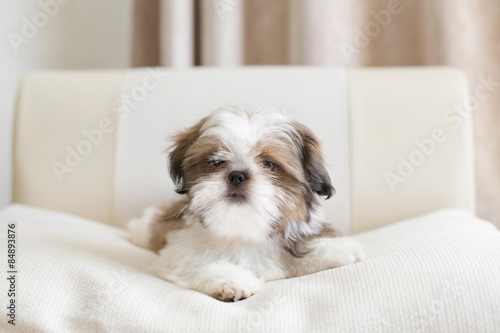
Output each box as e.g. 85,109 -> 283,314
169,107 -> 334,242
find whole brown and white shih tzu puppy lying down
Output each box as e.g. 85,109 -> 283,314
129,107 -> 363,301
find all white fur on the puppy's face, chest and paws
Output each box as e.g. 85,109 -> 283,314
129,107 -> 363,301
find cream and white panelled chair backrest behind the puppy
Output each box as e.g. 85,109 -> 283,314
13,67 -> 474,233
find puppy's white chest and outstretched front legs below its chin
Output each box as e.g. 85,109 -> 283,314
135,208 -> 364,301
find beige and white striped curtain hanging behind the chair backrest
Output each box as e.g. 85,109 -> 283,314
133,0 -> 500,226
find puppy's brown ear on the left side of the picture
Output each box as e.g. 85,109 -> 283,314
168,119 -> 205,194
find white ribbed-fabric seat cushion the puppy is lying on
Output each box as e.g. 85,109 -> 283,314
0,205 -> 500,332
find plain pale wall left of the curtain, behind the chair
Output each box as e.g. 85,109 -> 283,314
0,0 -> 133,208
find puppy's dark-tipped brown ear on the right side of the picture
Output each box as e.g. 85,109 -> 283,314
296,124 -> 335,199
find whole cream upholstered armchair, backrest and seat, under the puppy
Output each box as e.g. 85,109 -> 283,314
0,67 -> 500,332
